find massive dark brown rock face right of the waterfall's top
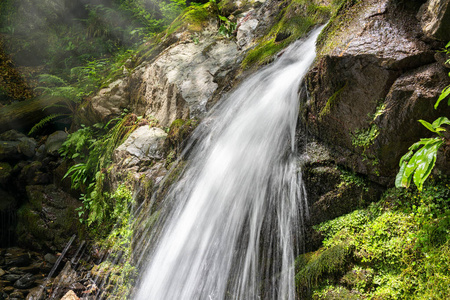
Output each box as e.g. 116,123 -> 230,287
301,0 -> 449,184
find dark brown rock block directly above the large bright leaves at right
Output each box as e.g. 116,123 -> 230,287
370,63 -> 450,174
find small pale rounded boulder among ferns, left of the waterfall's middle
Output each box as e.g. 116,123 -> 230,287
114,126 -> 167,168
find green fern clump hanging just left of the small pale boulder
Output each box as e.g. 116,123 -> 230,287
60,114 -> 140,231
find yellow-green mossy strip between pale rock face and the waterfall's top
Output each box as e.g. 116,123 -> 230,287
242,0 -> 341,69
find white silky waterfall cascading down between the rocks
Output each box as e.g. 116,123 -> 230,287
135,29 -> 319,300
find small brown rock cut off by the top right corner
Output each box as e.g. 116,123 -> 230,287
417,0 -> 450,42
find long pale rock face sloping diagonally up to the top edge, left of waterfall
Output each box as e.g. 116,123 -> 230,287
76,0 -> 292,126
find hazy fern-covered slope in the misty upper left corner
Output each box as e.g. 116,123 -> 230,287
0,0 -> 208,107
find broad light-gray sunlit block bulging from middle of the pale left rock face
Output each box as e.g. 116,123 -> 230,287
130,37 -> 238,126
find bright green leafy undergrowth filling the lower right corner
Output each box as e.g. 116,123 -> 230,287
296,177 -> 450,299
